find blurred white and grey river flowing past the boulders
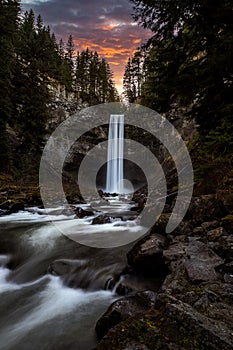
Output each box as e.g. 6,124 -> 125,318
0,202 -> 138,350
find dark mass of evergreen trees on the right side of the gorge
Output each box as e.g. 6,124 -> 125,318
124,0 -> 233,186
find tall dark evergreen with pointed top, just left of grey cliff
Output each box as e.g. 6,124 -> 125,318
14,10 -> 53,152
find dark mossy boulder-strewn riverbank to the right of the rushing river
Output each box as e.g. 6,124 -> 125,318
96,195 -> 233,350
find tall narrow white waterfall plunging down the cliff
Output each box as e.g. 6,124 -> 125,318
106,114 -> 125,194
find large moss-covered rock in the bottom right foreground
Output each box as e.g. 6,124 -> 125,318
97,294 -> 232,350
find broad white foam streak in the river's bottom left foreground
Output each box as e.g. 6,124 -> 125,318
0,276 -> 113,349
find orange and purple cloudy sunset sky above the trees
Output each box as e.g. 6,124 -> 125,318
21,0 -> 151,93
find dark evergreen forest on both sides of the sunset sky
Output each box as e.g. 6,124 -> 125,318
0,0 -> 233,191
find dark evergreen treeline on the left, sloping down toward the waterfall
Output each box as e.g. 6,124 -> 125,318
0,0 -> 118,171
